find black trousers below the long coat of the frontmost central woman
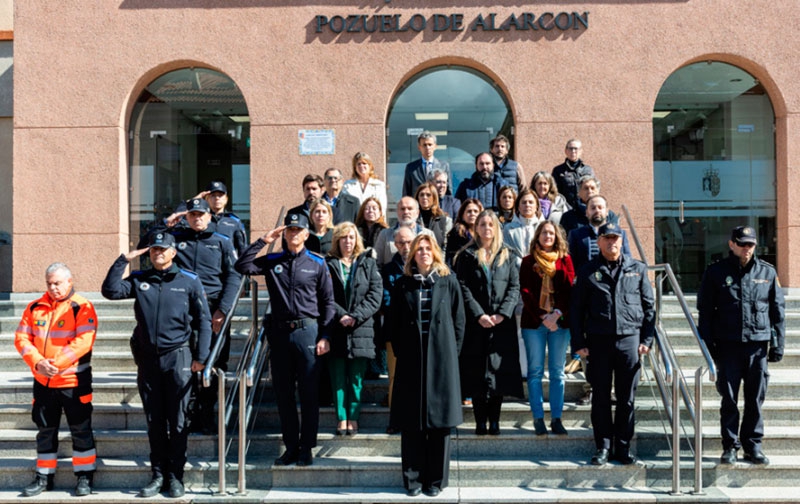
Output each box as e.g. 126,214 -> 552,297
400,428 -> 450,490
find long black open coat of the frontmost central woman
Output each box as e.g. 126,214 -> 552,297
385,275 -> 465,430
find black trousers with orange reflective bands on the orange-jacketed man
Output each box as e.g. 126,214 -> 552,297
31,378 -> 97,474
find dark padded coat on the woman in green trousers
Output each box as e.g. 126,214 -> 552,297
326,249 -> 383,359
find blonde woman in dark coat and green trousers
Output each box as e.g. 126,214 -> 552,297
327,222 -> 383,436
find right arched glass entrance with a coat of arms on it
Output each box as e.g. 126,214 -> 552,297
653,61 -> 777,291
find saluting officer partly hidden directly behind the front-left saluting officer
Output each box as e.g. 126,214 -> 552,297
145,198 -> 242,434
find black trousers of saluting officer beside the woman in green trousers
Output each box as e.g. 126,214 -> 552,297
269,324 -> 320,451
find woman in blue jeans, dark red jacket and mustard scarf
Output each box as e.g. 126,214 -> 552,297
519,221 -> 575,436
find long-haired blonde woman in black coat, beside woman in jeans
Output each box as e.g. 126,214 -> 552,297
454,210 -> 523,435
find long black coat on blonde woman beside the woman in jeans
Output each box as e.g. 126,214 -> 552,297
454,245 -> 523,397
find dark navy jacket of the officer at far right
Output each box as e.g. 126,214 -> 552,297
697,253 -> 785,354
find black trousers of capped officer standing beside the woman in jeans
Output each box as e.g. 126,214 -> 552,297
589,334 -> 641,452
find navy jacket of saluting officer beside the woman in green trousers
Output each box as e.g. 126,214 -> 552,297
235,238 -> 336,339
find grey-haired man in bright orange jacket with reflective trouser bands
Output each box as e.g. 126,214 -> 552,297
14,263 -> 97,497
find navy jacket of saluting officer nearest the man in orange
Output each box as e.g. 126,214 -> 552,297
102,255 -> 211,363
